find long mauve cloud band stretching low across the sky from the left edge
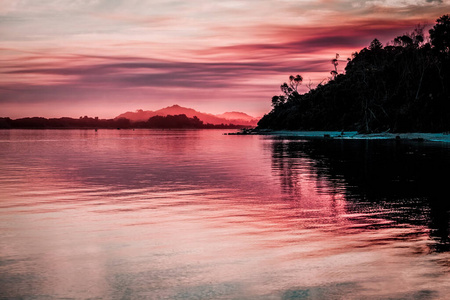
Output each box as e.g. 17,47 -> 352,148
3,57 -> 321,89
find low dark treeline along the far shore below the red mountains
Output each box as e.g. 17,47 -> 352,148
0,115 -> 245,129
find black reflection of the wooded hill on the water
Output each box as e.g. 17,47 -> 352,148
272,139 -> 450,251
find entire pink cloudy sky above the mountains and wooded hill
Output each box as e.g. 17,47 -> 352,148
0,0 -> 450,118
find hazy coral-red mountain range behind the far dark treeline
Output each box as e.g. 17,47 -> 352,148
114,105 -> 259,126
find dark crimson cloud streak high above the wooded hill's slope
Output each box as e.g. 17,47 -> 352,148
194,19 -> 426,63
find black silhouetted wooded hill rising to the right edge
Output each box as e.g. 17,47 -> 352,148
258,15 -> 450,133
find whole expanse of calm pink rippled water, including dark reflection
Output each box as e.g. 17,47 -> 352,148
0,130 -> 450,299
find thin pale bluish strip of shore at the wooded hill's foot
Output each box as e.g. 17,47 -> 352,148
229,130 -> 450,143
